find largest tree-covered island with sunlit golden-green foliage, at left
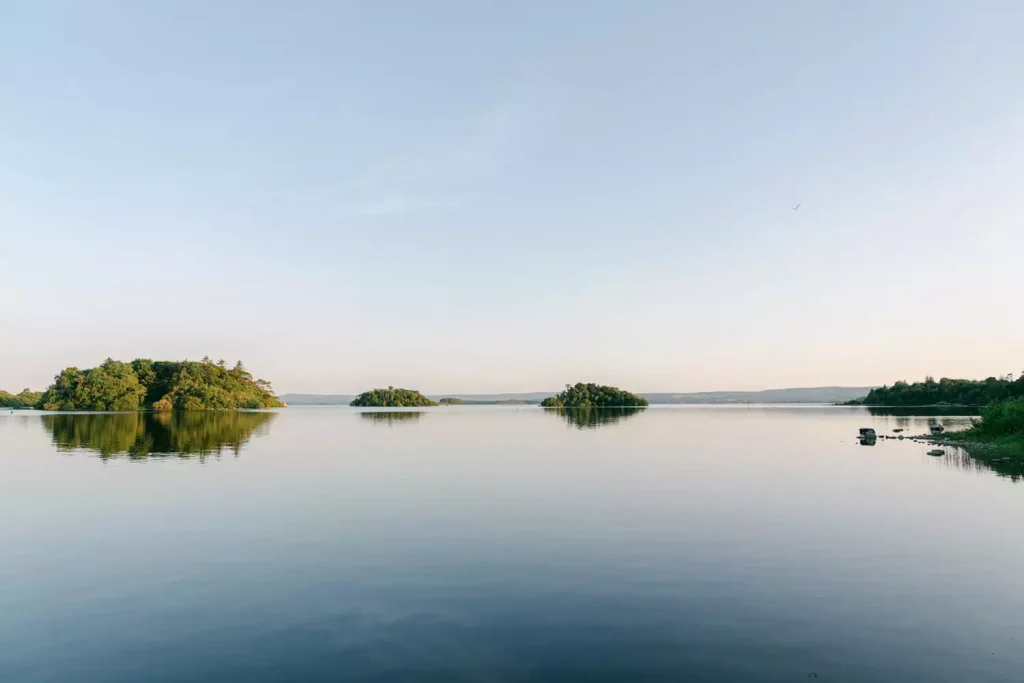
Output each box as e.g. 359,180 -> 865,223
6,358 -> 284,411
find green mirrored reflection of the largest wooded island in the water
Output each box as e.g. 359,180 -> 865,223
41,412 -> 276,459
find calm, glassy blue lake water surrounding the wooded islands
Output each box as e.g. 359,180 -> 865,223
0,407 -> 1024,683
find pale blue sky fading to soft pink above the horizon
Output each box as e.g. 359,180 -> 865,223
0,0 -> 1024,393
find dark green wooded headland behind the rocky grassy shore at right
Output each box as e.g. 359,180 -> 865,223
846,374 -> 1024,407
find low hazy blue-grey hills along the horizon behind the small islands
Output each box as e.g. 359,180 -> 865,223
280,387 -> 873,405
